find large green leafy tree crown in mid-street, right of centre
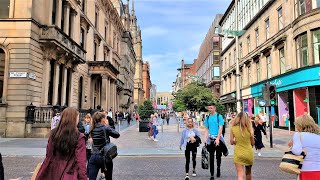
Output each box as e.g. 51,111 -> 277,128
173,82 -> 225,114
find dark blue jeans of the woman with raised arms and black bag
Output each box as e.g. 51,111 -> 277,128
88,154 -> 113,180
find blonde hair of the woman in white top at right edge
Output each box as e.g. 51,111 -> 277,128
294,113 -> 320,134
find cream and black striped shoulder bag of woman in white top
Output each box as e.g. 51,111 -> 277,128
279,133 -> 307,174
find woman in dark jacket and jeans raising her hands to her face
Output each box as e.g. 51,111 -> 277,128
88,112 -> 120,180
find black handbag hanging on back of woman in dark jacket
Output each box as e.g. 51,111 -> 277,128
102,129 -> 118,164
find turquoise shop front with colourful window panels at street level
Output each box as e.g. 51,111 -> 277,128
251,65 -> 320,127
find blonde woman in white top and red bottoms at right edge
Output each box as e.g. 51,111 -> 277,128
289,114 -> 320,180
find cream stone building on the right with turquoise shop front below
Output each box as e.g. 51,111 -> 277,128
220,0 -> 320,128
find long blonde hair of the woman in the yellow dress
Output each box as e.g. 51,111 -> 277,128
231,112 -> 252,136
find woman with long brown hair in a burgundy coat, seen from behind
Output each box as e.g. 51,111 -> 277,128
36,107 -> 88,180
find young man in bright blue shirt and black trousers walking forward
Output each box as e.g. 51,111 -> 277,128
203,103 -> 224,180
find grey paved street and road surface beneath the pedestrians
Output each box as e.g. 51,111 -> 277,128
0,118 -> 295,180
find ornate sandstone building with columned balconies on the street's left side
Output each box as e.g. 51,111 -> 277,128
0,0 -> 141,137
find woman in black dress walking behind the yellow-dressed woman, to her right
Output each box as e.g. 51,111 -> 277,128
253,115 -> 268,156
